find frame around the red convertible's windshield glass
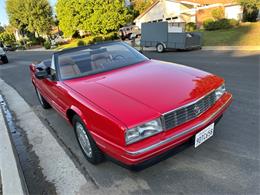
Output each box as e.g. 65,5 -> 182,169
53,41 -> 149,81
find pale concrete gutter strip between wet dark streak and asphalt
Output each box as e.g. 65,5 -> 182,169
0,78 -> 94,195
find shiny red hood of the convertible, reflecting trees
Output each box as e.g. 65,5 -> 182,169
65,60 -> 223,126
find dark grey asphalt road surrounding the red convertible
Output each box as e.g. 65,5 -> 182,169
0,51 -> 260,194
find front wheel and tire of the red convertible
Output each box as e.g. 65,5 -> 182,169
72,115 -> 104,165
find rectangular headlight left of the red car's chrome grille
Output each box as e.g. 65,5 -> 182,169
125,118 -> 163,144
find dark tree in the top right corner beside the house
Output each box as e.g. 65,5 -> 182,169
238,0 -> 260,22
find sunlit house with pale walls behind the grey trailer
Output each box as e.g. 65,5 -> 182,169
134,0 -> 243,28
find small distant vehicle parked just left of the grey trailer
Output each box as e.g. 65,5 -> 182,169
118,25 -> 141,40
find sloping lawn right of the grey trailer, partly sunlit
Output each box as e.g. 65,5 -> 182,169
202,22 -> 260,46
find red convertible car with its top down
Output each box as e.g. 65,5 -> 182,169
30,42 -> 232,165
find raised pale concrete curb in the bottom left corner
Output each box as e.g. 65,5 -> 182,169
0,95 -> 29,195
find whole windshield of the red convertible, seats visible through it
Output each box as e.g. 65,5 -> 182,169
56,42 -> 148,80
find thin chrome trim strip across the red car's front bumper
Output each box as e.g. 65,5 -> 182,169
126,95 -> 232,156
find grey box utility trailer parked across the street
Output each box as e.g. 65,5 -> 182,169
140,22 -> 202,53
